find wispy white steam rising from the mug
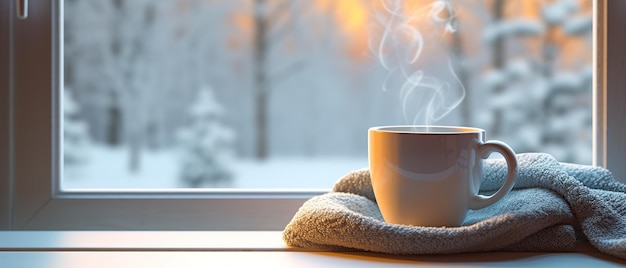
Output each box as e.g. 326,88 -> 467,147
370,0 -> 465,125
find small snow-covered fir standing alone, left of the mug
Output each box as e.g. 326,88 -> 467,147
179,87 -> 234,187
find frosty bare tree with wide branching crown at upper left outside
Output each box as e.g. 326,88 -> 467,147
64,0 -> 236,172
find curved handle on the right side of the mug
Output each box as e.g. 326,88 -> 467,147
469,140 -> 517,210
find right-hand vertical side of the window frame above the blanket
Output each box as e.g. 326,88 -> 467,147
593,0 -> 626,183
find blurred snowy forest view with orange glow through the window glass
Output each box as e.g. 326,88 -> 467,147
62,0 -> 592,188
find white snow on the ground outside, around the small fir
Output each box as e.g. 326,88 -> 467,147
62,147 -> 367,189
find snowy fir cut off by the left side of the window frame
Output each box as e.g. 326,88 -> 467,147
63,89 -> 89,169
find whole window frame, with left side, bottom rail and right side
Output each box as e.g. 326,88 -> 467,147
0,0 -> 626,230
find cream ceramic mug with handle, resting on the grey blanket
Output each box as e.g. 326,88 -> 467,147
368,126 -> 517,227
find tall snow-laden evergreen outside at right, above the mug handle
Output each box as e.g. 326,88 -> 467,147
481,0 -> 592,163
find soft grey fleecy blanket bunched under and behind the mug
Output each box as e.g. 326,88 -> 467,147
283,154 -> 626,259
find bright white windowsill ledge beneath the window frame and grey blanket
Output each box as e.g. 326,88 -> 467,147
0,231 -> 626,267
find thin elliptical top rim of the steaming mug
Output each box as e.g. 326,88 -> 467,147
369,125 -> 485,135
